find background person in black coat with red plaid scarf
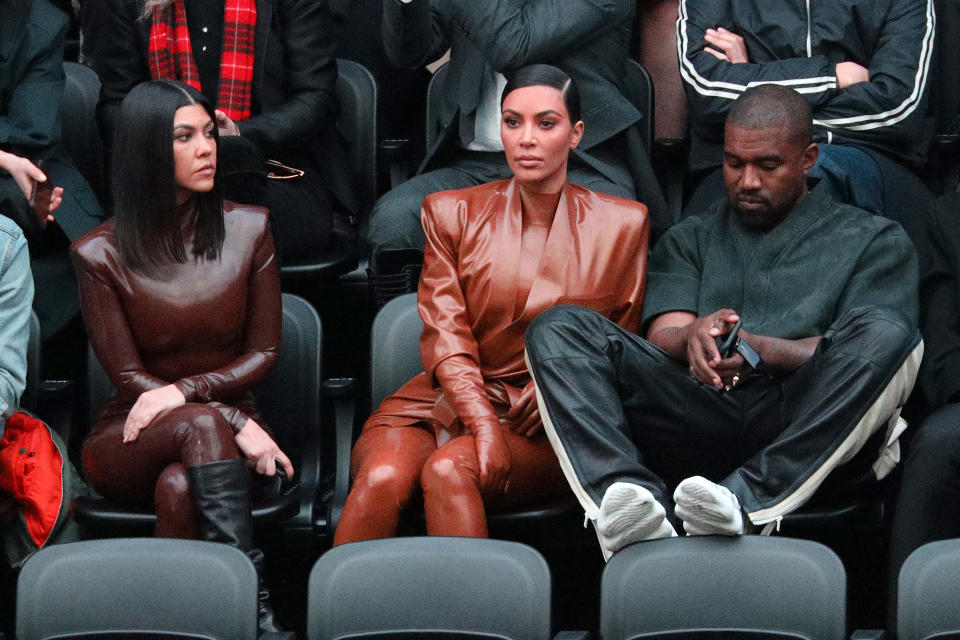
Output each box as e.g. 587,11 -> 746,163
81,0 -> 356,263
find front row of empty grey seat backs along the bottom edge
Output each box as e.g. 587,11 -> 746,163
16,536 -> 960,640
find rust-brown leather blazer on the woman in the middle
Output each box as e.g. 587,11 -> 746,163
367,180 -> 649,439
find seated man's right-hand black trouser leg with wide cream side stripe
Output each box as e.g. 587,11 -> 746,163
722,307 -> 923,524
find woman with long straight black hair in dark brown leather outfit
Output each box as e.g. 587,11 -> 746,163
71,80 -> 293,632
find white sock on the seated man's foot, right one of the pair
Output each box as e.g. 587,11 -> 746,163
673,476 -> 744,536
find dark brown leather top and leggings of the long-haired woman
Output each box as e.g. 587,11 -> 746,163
71,202 -> 281,532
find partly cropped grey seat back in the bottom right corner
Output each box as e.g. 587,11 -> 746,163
897,536 -> 960,640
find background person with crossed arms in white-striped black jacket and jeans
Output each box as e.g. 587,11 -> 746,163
677,0 -> 935,251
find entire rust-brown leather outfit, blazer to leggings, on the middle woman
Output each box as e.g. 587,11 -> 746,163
335,180 -> 648,544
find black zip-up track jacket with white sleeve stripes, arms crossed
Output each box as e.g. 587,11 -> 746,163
677,0 -> 936,171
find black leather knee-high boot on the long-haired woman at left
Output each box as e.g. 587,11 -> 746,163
187,460 -> 296,640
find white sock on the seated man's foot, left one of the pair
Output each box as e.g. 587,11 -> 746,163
596,482 -> 677,560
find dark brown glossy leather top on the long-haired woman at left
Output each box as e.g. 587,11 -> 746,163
71,203 -> 281,442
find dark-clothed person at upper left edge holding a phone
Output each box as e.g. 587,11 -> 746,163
0,0 -> 103,338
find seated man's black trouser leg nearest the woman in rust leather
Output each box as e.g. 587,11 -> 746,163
526,306 -> 741,516
